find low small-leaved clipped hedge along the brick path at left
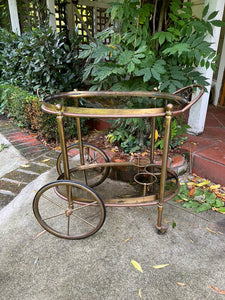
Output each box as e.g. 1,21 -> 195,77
0,83 -> 87,141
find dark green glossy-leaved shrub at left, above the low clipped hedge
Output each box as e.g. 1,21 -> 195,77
0,27 -> 81,93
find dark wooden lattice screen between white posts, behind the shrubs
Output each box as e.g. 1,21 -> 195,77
3,0 -> 109,43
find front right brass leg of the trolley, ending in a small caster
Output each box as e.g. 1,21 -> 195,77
156,104 -> 173,233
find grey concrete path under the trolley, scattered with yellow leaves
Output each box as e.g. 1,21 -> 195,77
0,168 -> 225,300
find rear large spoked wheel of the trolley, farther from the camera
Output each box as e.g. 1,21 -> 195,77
56,143 -> 110,187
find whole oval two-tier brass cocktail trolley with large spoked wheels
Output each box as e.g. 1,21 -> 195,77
33,85 -> 204,239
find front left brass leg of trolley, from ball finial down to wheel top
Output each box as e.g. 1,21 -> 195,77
57,105 -> 70,180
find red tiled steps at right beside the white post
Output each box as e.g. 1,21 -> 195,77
182,106 -> 225,186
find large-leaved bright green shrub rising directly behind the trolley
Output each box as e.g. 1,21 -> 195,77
79,0 -> 224,154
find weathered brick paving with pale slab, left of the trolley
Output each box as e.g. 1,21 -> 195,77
0,120 -> 54,209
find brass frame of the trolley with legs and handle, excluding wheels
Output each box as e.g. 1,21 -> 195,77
36,85 -> 204,233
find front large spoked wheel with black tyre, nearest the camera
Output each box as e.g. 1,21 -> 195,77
33,180 -> 105,240
